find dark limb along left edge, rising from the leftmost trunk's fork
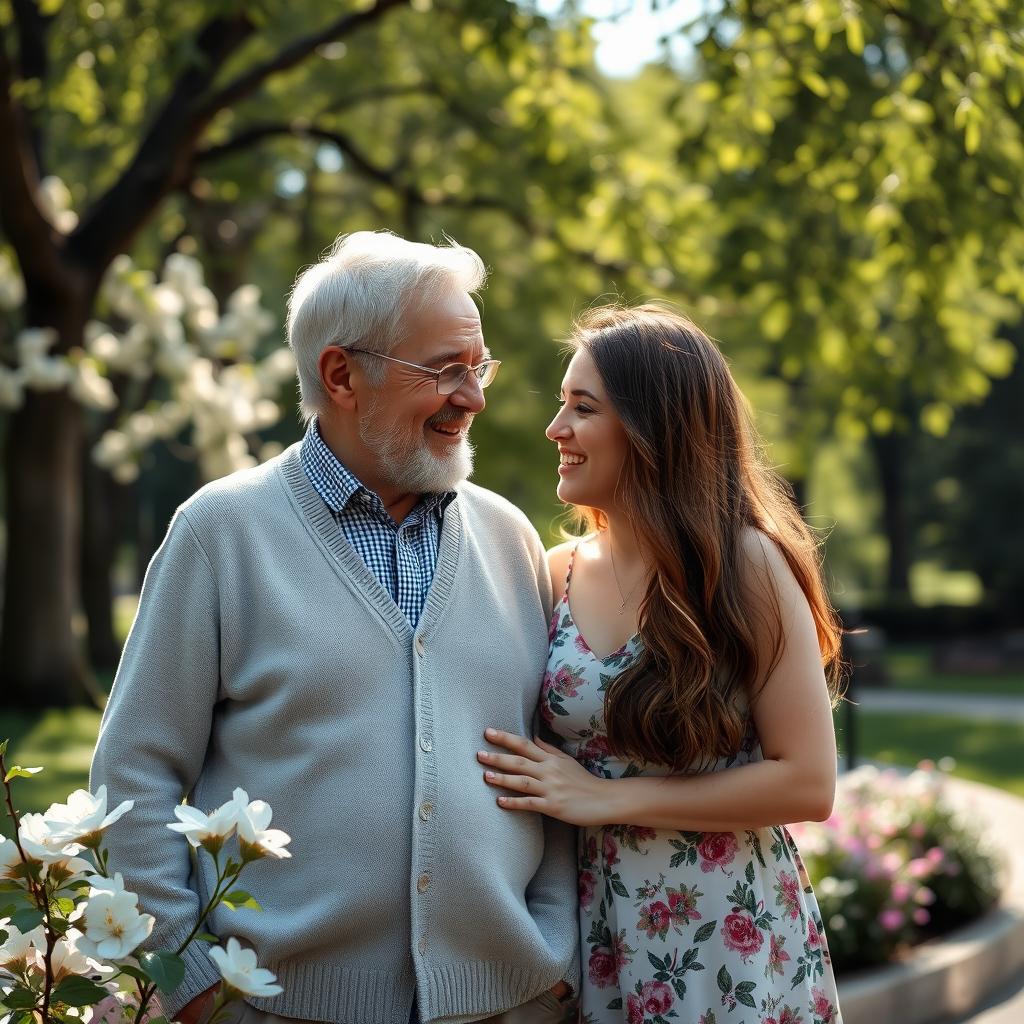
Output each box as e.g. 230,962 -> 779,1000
0,26 -> 62,292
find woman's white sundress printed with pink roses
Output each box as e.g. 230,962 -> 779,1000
541,552 -> 842,1024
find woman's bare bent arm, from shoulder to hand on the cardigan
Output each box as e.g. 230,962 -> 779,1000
480,530 -> 836,831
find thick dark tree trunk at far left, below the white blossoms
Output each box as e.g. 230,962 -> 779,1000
0,392 -> 85,708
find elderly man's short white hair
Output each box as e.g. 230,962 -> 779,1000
288,231 -> 487,422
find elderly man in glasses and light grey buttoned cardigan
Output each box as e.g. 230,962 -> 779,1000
92,231 -> 579,1024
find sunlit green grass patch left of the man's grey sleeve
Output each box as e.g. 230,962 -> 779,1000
0,708 -> 100,836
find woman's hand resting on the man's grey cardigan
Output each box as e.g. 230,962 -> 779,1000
476,729 -> 608,825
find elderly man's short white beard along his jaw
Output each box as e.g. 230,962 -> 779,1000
359,401 -> 473,495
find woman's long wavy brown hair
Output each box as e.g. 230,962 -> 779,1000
570,305 -> 843,771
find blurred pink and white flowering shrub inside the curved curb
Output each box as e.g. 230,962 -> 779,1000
791,762 -> 998,971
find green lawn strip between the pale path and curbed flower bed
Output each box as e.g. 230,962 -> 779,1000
836,711 -> 1024,797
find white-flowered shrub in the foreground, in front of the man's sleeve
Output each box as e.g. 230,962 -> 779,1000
0,740 -> 291,1024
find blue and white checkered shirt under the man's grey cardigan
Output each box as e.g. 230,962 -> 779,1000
300,420 -> 455,627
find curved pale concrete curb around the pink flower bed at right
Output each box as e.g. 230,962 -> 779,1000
839,778 -> 1024,1024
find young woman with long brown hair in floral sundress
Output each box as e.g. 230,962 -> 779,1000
479,305 -> 841,1024
